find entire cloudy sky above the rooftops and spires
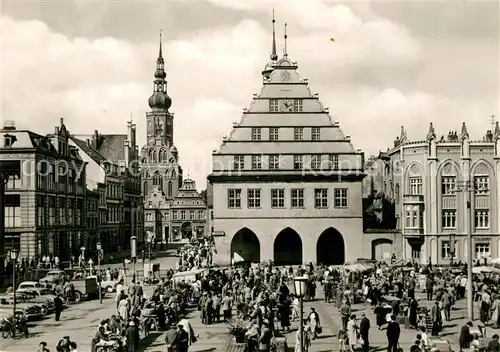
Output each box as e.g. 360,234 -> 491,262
0,0 -> 500,189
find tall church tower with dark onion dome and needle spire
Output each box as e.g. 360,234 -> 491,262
141,32 -> 182,200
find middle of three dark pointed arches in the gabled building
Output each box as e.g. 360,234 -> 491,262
274,227 -> 302,265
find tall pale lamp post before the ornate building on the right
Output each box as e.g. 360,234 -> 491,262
453,180 -> 485,321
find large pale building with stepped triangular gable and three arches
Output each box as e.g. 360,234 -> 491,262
207,20 -> 390,265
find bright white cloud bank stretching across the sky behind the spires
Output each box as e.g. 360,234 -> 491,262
0,0 -> 496,188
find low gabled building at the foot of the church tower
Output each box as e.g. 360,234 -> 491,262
144,179 -> 207,242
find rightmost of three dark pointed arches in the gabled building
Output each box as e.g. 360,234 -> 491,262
316,227 -> 345,265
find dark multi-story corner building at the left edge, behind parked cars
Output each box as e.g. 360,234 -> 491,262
0,119 -> 86,261
